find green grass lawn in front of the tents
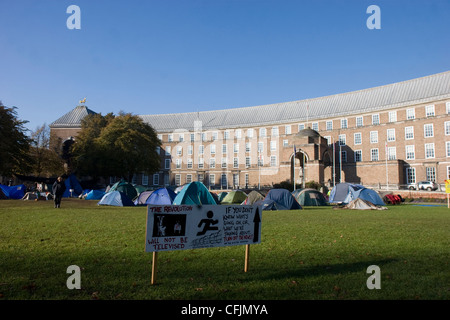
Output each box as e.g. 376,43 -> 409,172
0,199 -> 450,300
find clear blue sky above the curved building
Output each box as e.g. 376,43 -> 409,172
0,0 -> 450,130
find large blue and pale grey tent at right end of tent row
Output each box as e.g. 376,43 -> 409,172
329,183 -> 385,206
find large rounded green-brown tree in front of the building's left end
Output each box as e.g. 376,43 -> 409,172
72,113 -> 160,180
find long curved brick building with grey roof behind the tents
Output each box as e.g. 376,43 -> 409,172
50,71 -> 450,189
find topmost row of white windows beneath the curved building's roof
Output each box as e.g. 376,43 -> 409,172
158,102 -> 450,142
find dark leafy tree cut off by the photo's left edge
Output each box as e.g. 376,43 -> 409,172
0,101 -> 32,176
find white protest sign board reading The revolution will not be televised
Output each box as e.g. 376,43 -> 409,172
145,205 -> 262,252
